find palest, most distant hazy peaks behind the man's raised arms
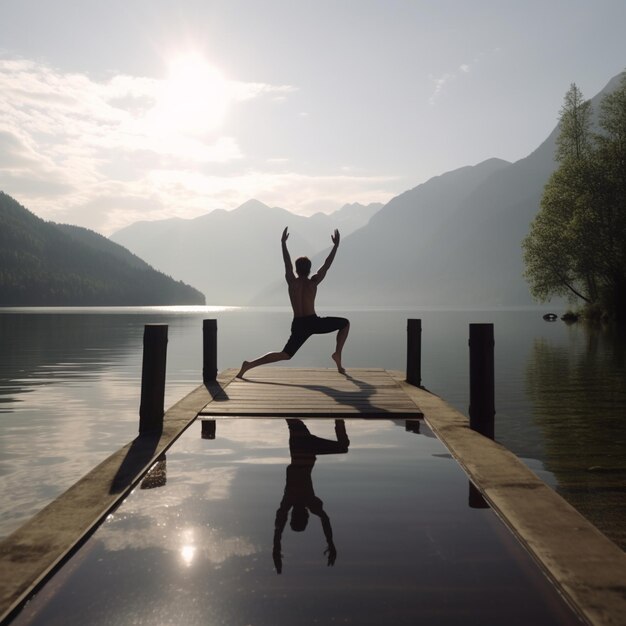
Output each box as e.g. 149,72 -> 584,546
111,200 -> 382,304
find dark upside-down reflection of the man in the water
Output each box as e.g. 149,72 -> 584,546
272,419 -> 350,574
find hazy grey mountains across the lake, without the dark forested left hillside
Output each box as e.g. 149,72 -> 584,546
112,70 -> 620,308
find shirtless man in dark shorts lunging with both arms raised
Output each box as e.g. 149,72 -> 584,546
237,228 -> 350,378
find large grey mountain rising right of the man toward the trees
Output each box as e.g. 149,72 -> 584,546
302,76 -> 621,307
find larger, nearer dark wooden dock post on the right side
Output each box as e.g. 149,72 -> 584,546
469,324 -> 496,439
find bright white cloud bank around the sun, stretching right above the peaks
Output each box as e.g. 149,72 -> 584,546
0,59 -> 394,234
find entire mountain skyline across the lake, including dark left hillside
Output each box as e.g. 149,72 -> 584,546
0,70 -> 620,308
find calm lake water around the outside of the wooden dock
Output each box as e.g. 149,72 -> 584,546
0,307 -> 626,547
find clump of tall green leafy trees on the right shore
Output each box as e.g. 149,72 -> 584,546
522,74 -> 626,319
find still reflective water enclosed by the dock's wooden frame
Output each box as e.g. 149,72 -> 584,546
11,418 -> 582,626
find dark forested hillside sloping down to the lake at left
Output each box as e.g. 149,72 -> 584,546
0,192 -> 205,306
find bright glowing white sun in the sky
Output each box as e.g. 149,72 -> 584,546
152,53 -> 231,134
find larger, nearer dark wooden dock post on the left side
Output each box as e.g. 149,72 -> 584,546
139,324 -> 167,435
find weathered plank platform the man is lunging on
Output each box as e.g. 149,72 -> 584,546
200,366 -> 422,418
